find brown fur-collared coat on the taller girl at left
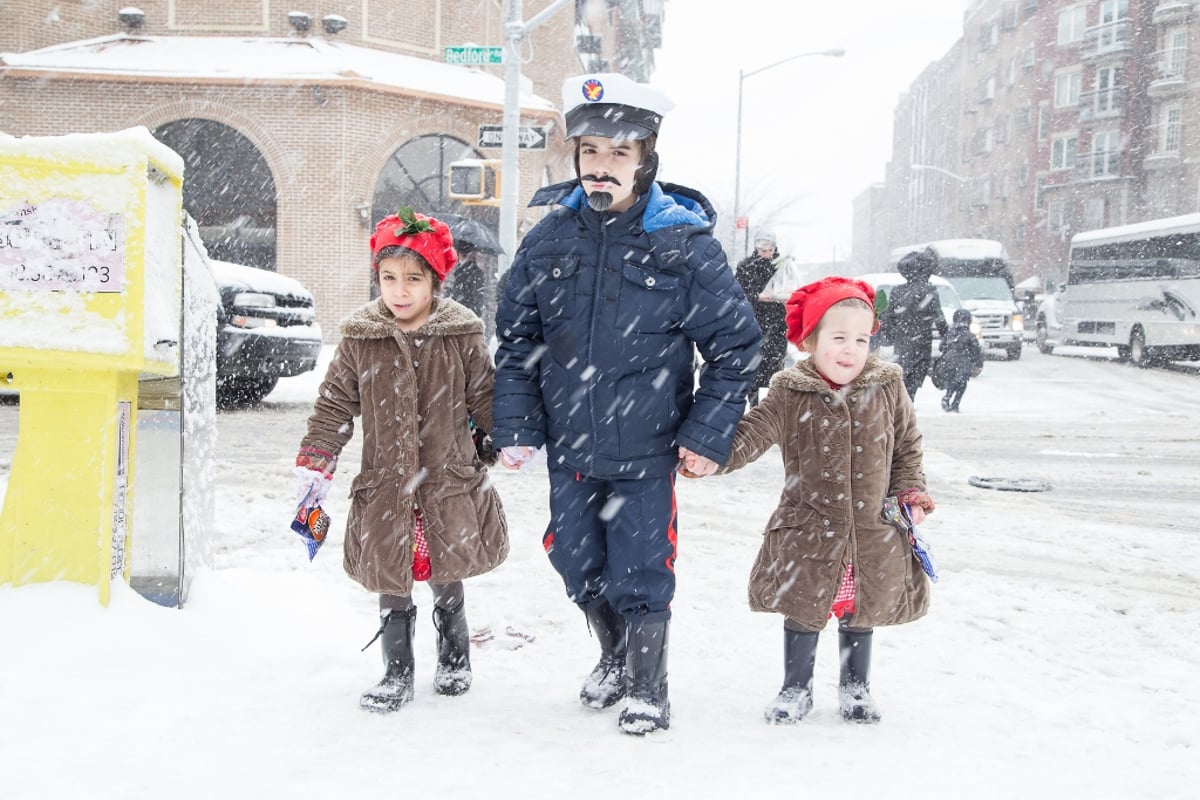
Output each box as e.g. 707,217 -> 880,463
301,297 -> 509,595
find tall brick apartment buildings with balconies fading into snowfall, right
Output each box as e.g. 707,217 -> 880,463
873,0 -> 1200,282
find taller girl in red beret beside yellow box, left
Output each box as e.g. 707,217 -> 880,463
296,209 -> 509,711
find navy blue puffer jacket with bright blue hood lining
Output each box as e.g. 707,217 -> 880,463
492,181 -> 761,479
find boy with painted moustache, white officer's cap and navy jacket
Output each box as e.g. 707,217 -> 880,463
492,74 -> 761,734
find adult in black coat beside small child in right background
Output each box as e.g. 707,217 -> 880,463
881,248 -> 949,398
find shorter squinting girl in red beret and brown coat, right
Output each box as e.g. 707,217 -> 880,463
722,276 -> 934,723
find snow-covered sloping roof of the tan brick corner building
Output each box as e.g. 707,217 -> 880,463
0,34 -> 557,113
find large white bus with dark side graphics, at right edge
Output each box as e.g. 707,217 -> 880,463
1037,213 -> 1200,366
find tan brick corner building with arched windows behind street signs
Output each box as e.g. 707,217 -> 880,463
0,0 -> 662,337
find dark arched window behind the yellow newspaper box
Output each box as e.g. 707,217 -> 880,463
154,119 -> 276,270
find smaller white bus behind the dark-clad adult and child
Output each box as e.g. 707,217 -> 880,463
890,239 -> 1025,360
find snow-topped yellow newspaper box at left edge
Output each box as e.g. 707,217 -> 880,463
0,128 -> 184,604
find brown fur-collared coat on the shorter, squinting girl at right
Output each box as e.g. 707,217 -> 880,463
722,356 -> 929,631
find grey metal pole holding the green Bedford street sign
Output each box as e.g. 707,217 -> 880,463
499,0 -> 574,275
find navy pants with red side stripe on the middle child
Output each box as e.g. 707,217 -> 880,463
542,467 -> 676,622
